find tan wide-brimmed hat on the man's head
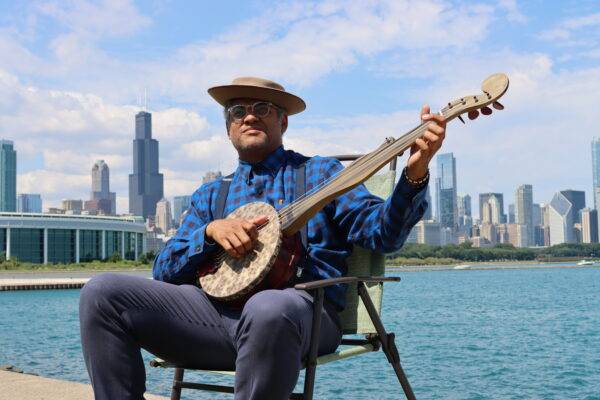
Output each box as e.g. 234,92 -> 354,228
208,76 -> 306,115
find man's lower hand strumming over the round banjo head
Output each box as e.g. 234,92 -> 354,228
205,215 -> 269,258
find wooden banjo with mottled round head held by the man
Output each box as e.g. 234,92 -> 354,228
198,73 -> 508,303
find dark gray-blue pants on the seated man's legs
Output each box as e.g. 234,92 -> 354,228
79,274 -> 341,400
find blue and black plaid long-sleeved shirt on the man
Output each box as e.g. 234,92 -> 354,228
153,147 -> 427,309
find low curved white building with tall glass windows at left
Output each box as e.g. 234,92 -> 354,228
0,212 -> 146,264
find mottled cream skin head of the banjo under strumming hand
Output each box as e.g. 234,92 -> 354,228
200,202 -> 281,301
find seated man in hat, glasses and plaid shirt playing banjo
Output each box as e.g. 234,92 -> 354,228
80,78 -> 445,400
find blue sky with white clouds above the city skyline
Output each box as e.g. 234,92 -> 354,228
0,0 -> 600,219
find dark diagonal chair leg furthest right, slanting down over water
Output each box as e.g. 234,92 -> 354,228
358,282 -> 415,400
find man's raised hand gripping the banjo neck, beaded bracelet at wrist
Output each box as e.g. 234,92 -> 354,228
406,104 -> 446,181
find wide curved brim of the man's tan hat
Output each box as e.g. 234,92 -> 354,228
208,85 -> 306,115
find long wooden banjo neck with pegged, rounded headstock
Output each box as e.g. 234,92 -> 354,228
278,73 -> 508,236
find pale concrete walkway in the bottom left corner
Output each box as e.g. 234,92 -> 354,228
0,371 -> 167,400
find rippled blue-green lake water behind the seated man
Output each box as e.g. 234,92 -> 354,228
0,268 -> 600,400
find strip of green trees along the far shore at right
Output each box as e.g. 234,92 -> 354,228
387,242 -> 600,265
